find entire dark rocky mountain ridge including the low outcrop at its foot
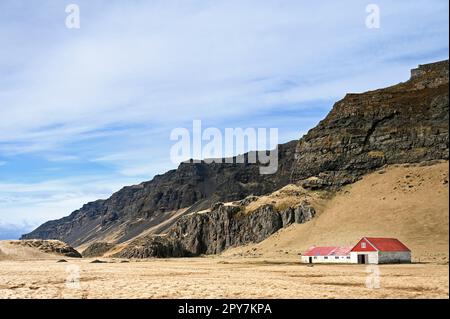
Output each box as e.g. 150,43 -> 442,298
22,61 -> 449,252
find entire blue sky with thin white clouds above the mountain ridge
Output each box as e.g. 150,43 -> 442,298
0,0 -> 449,239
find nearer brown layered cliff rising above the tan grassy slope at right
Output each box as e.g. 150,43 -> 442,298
293,61 -> 449,188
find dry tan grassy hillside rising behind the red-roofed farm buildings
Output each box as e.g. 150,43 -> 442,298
224,162 -> 449,262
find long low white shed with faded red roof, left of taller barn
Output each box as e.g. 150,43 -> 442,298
301,246 -> 352,264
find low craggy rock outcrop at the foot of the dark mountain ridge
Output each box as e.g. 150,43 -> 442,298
114,202 -> 315,258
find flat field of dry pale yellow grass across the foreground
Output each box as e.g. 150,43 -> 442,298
0,257 -> 449,298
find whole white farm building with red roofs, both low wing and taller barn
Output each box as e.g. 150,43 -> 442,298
301,237 -> 411,264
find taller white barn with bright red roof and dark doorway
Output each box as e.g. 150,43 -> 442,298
350,237 -> 411,264
